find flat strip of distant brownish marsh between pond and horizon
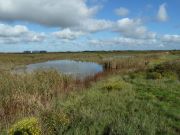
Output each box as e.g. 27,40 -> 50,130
0,51 -> 177,71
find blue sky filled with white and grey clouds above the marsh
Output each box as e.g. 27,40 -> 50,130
0,0 -> 180,52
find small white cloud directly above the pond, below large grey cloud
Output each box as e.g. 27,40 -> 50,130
53,28 -> 85,40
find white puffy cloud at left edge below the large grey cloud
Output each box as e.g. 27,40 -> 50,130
0,24 -> 45,44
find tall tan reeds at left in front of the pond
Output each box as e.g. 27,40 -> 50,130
0,71 -> 80,130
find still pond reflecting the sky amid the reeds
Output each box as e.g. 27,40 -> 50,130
17,60 -> 103,79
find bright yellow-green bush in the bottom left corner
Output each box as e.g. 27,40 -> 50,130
9,117 -> 41,135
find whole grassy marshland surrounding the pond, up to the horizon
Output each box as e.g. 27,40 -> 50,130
0,51 -> 180,135
